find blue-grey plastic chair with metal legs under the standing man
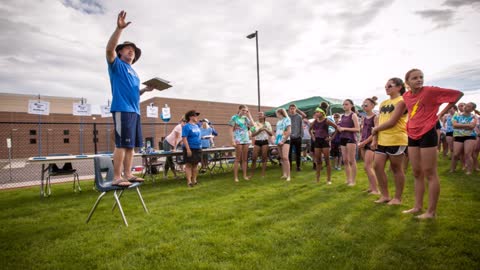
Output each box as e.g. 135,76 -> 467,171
86,156 -> 148,227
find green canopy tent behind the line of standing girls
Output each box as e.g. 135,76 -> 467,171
265,96 -> 361,118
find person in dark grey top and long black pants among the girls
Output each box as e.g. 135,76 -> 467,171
288,104 -> 307,172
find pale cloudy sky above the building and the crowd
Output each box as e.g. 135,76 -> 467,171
0,0 -> 480,111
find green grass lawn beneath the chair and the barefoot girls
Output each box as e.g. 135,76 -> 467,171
0,156 -> 480,269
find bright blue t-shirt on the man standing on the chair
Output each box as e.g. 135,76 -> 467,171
108,57 -> 140,115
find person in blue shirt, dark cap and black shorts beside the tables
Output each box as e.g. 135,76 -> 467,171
182,110 -> 202,187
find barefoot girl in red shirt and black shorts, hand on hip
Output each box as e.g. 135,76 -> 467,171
403,69 -> 463,219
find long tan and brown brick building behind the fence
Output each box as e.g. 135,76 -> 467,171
0,93 -> 275,159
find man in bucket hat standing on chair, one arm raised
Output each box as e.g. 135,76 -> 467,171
106,10 -> 153,186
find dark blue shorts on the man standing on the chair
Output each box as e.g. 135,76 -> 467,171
112,112 -> 143,148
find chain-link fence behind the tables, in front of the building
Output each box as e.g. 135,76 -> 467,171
0,122 -> 236,189
